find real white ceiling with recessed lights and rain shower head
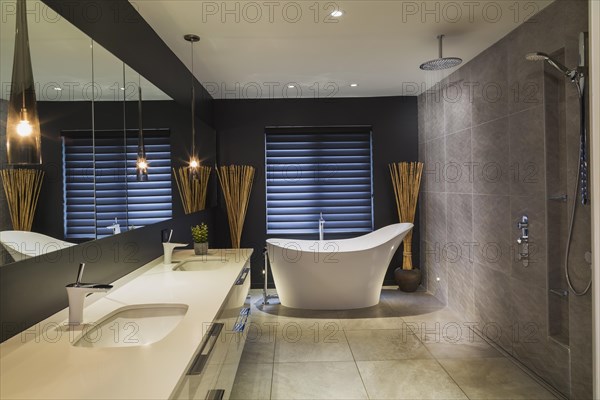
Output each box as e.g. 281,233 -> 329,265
131,0 -> 553,98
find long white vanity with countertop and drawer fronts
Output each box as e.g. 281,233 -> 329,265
0,249 -> 252,400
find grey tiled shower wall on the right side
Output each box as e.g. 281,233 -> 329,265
419,0 -> 592,398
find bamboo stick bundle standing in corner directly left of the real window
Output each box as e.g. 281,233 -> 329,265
217,165 -> 254,249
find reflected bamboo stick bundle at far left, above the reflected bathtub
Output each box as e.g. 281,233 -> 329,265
0,168 -> 44,231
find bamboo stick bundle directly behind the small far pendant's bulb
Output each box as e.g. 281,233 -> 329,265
173,165 -> 212,214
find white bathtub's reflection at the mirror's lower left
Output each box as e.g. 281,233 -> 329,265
0,231 -> 75,261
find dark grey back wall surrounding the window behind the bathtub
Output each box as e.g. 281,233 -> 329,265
214,97 -> 419,287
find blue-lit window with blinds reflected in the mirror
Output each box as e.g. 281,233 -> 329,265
63,129 -> 172,239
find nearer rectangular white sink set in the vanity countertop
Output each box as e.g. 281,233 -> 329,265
74,304 -> 188,347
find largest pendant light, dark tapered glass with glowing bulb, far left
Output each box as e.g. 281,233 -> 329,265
6,0 -> 42,164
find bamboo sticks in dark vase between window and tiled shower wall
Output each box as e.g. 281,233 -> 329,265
389,162 -> 423,269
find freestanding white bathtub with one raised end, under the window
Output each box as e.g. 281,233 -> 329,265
267,223 -> 413,310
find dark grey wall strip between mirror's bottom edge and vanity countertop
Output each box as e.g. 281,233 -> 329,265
0,209 -> 215,341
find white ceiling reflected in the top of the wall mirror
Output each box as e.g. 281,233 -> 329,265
0,0 -> 169,101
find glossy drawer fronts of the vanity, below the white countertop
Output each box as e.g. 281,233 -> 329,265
171,261 -> 250,400
